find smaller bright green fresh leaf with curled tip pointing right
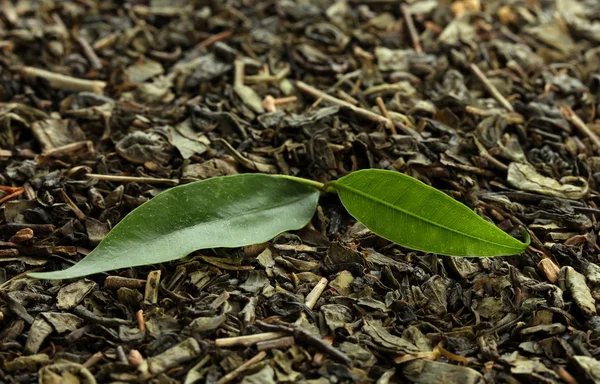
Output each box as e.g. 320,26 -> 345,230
327,169 -> 529,257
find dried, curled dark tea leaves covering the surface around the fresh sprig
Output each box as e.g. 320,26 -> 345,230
0,0 -> 600,384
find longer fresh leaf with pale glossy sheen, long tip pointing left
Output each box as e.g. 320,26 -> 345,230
29,174 -> 319,279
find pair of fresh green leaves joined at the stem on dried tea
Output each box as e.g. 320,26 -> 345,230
29,169 -> 529,279
